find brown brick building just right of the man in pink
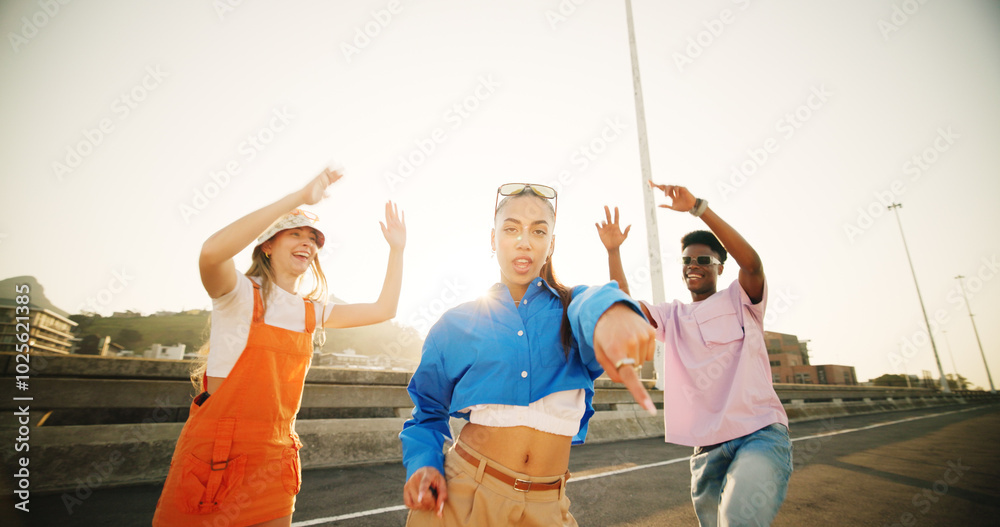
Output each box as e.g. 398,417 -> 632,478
764,331 -> 858,386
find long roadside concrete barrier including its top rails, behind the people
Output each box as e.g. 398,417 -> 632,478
0,354 -> 996,496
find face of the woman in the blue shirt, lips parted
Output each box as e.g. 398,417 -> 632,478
491,194 -> 555,300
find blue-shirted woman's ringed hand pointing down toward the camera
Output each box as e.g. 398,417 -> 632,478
594,303 -> 656,415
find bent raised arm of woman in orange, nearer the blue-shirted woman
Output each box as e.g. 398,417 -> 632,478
323,201 -> 406,328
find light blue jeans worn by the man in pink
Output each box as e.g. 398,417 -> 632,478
691,423 -> 792,527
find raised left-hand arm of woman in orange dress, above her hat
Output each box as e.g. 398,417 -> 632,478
198,168 -> 343,298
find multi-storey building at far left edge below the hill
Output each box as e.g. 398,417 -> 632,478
0,298 -> 77,354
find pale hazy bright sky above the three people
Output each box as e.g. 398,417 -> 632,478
0,0 -> 1000,386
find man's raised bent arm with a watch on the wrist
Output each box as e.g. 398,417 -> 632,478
649,181 -> 764,304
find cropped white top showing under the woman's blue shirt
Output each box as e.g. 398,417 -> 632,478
463,388 -> 587,437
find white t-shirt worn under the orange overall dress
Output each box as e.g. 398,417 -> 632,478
207,273 -> 329,377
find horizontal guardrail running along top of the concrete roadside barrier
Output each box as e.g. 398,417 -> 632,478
0,353 -> 984,426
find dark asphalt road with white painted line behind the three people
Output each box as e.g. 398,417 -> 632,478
0,405 -> 1000,527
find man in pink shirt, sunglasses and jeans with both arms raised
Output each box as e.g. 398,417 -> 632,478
597,182 -> 792,526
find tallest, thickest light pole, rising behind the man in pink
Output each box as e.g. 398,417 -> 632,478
625,0 -> 665,389
